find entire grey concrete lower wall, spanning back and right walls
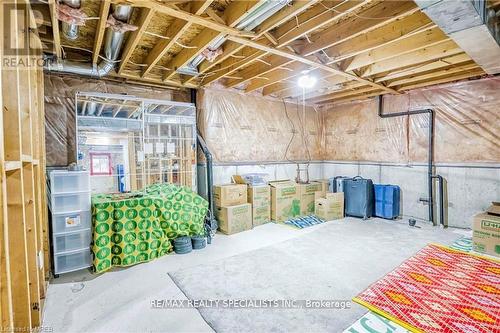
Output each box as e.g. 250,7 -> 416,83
198,161 -> 500,228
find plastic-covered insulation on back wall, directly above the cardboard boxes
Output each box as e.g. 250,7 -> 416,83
197,89 -> 323,162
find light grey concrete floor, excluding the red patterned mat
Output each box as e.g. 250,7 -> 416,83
44,218 -> 470,332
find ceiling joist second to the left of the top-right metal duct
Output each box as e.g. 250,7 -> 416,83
276,0 -> 371,47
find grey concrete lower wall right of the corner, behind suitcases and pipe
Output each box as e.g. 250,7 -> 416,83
323,161 -> 500,228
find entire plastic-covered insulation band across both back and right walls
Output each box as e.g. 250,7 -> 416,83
198,77 -> 500,163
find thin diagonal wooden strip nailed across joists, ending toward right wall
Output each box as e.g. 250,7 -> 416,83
228,36 -> 399,94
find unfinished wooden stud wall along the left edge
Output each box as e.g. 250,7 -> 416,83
0,0 -> 50,331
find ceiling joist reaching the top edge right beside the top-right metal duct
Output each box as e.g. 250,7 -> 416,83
300,1 -> 419,56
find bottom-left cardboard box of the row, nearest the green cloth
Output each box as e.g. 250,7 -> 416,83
215,203 -> 252,235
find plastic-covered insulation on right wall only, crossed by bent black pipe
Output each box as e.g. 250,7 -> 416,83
321,77 -> 500,163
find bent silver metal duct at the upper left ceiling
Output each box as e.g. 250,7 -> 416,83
43,5 -> 132,78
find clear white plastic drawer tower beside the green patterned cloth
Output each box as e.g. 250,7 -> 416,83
47,170 -> 92,276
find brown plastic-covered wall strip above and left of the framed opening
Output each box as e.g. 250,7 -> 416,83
44,74 -> 190,166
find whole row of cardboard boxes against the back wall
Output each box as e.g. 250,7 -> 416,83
214,175 -> 344,234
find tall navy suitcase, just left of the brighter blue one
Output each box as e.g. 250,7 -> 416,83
344,176 -> 375,219
